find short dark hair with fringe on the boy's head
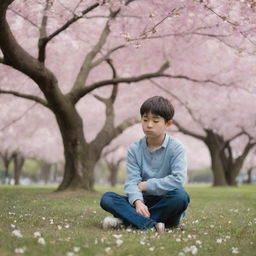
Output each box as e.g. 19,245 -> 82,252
140,96 -> 174,122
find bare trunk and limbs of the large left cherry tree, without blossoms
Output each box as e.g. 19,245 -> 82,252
0,0 -> 168,190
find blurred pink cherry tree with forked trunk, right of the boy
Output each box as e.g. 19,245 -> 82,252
154,83 -> 256,186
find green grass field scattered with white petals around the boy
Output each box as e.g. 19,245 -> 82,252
0,186 -> 256,256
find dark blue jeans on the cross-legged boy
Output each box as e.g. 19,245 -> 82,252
100,189 -> 190,230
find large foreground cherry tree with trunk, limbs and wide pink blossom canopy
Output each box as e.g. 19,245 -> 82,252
0,0 -> 255,190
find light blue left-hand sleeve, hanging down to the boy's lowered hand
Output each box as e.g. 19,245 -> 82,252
124,147 -> 144,205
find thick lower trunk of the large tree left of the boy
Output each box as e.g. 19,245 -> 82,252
55,104 -> 97,191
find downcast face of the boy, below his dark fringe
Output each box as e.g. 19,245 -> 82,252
141,112 -> 172,138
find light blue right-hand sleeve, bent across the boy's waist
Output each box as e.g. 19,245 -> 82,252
146,145 -> 187,196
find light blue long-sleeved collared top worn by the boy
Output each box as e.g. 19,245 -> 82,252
124,134 -> 187,205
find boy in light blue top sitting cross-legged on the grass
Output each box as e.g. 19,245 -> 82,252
100,96 -> 190,233
